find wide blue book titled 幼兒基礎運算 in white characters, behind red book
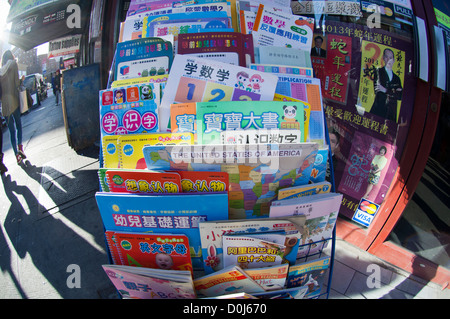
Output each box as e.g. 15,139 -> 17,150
95,192 -> 228,270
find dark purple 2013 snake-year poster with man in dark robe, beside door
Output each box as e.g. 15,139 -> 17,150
318,21 -> 416,219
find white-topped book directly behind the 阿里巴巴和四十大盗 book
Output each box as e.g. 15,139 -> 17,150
199,216 -> 306,274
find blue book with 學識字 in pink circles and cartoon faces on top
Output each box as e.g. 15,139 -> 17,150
99,83 -> 161,137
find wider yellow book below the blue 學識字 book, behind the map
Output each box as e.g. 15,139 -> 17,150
116,133 -> 194,169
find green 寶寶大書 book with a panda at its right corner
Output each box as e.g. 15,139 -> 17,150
197,101 -> 305,145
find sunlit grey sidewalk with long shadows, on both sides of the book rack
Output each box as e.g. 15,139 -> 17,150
0,91 -> 450,299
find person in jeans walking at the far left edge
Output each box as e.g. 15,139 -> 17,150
0,50 -> 26,164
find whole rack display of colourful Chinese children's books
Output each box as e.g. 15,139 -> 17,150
96,0 -> 342,299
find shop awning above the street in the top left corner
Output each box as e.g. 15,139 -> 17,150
7,0 -> 92,51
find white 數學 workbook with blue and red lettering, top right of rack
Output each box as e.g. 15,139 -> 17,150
252,4 -> 314,51
